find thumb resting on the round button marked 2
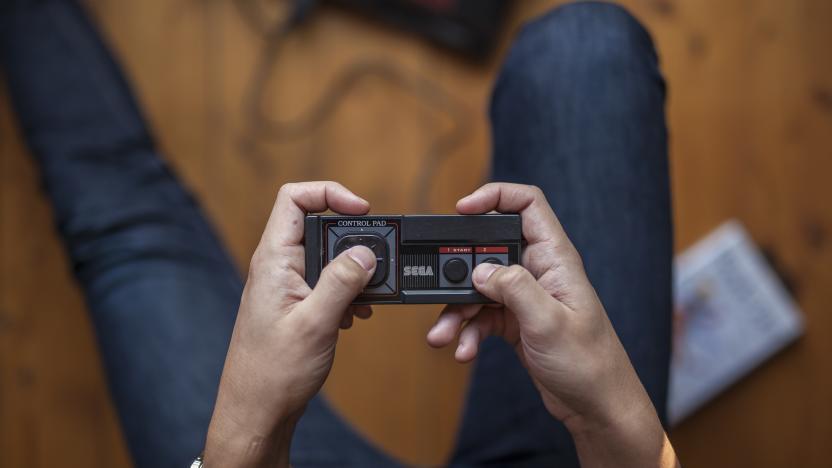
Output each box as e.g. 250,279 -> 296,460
472,263 -> 564,336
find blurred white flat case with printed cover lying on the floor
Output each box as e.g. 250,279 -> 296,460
668,221 -> 803,425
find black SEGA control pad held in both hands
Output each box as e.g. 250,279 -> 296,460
304,214 -> 522,304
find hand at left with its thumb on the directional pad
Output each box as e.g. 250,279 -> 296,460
205,182 -> 376,467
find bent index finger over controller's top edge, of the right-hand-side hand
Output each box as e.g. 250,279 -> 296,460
456,182 -> 571,246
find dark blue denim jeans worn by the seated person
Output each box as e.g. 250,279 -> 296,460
0,0 -> 672,467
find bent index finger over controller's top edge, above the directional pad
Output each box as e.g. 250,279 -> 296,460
260,181 -> 370,248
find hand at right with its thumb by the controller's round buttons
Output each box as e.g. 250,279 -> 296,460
427,183 -> 672,467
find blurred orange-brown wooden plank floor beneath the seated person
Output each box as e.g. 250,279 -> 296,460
0,0 -> 832,468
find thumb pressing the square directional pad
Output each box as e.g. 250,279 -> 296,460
303,245 -> 376,327
